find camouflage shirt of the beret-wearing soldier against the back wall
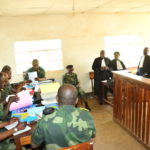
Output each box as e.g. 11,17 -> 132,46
63,72 -> 79,86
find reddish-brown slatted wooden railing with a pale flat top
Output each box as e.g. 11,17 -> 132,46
113,72 -> 150,148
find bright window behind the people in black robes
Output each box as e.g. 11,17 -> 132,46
104,35 -> 143,67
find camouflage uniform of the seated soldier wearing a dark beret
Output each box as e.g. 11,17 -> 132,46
63,73 -> 87,101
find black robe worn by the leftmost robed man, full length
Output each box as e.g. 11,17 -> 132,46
92,57 -> 111,99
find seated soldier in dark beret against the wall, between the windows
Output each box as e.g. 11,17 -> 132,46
63,65 -> 91,111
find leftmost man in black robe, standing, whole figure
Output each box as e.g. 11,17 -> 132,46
92,50 -> 111,104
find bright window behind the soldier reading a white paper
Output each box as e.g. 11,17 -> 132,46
14,39 -> 64,74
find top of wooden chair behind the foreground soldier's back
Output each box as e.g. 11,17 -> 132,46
60,142 -> 93,150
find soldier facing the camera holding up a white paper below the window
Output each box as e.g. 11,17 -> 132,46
25,59 -> 46,81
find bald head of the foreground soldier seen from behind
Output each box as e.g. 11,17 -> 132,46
57,84 -> 78,105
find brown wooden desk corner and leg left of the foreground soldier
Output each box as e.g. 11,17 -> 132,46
13,124 -> 36,150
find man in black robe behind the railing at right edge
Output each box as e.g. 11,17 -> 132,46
137,47 -> 150,77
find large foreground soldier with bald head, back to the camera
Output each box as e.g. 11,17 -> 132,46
31,84 -> 96,150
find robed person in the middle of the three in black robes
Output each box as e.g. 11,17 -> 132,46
111,51 -> 126,71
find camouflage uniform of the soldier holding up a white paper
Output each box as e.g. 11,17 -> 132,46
25,67 -> 45,80
